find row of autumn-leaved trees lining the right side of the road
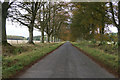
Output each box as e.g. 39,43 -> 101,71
71,1 -> 120,74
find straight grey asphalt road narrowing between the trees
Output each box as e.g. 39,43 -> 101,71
18,42 -> 114,78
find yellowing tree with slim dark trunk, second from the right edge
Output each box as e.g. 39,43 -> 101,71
92,2 -> 111,45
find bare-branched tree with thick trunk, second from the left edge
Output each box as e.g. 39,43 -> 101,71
11,2 -> 40,44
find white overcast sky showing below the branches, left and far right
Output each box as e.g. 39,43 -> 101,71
6,21 -> 117,37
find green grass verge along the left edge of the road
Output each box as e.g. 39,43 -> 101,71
2,43 -> 63,78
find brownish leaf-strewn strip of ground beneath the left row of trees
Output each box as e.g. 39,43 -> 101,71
2,43 -> 57,56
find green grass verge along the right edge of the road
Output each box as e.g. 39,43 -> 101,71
72,41 -> 120,73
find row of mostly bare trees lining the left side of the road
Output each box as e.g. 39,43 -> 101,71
2,0 -> 68,44
